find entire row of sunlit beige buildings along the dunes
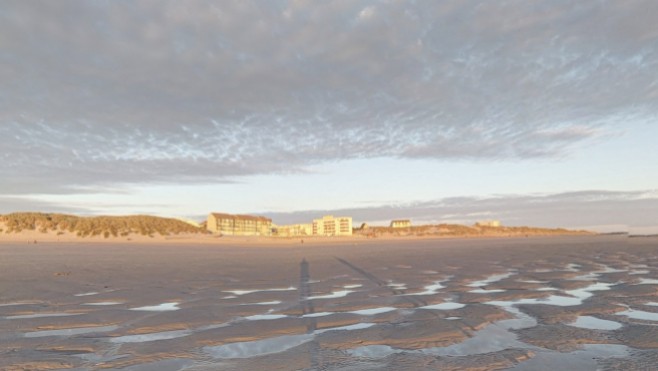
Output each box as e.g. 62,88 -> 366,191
206,213 -> 500,237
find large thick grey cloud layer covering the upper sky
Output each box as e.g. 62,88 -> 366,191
0,0 -> 658,194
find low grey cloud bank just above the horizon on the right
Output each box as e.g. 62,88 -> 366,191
267,190 -> 658,232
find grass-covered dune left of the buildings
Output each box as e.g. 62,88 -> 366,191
0,213 -> 204,238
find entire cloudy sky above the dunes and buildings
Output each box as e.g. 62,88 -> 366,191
0,0 -> 658,230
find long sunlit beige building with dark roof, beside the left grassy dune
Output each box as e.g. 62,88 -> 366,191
206,213 -> 272,236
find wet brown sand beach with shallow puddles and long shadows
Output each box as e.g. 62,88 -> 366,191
0,236 -> 658,370
